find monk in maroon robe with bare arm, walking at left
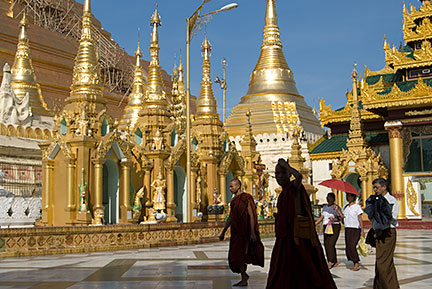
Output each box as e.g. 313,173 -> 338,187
219,179 -> 264,286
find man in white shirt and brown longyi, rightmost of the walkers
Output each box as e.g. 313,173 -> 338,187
372,178 -> 399,289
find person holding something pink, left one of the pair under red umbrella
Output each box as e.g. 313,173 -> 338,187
315,193 -> 341,269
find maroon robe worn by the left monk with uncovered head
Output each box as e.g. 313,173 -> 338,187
228,193 -> 264,273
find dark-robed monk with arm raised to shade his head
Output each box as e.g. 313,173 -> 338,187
266,159 -> 337,289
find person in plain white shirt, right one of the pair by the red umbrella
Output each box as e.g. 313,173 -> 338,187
334,193 -> 365,271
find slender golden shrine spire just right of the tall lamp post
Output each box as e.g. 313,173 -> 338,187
196,36 -> 219,118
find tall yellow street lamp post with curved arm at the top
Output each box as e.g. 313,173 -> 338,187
186,0 -> 238,222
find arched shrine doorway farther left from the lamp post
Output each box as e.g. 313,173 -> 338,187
102,159 -> 119,224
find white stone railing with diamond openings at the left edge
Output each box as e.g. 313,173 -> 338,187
0,196 -> 42,228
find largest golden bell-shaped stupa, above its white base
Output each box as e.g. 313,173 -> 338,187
225,0 -> 324,140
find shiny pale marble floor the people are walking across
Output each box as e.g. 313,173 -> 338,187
0,230 -> 432,289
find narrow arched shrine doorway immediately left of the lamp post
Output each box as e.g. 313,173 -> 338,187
174,166 -> 187,223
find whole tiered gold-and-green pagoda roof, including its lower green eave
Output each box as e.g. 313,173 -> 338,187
311,0 -> 432,159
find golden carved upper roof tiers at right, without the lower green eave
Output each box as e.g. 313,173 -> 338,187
320,1 -> 432,126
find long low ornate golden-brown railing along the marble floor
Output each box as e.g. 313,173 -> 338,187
0,220 -> 274,257
